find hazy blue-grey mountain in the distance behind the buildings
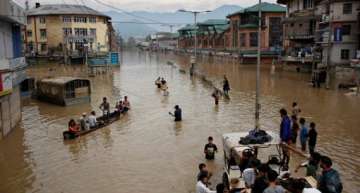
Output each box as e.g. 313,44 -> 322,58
105,5 -> 242,39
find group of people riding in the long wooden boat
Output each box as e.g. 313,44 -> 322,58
68,96 -> 130,134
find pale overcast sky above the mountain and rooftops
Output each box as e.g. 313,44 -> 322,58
15,0 -> 276,12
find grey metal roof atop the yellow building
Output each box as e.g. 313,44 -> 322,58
27,4 -> 110,18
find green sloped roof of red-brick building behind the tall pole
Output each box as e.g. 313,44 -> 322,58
227,2 -> 286,17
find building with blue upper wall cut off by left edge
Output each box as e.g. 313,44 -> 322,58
0,0 -> 26,140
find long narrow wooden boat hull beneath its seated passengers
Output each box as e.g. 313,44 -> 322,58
63,112 -> 121,140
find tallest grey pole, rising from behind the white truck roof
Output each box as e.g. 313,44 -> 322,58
255,0 -> 262,131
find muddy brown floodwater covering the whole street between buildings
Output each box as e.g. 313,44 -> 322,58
0,52 -> 360,193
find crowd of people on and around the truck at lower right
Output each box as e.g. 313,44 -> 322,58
196,102 -> 343,193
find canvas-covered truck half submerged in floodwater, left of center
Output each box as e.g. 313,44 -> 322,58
35,77 -> 91,106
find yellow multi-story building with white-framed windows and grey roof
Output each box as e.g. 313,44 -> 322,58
25,3 -> 112,56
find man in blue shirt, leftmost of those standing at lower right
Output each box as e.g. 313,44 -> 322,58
280,109 -> 291,171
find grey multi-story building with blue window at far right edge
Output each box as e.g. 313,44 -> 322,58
315,0 -> 360,66
